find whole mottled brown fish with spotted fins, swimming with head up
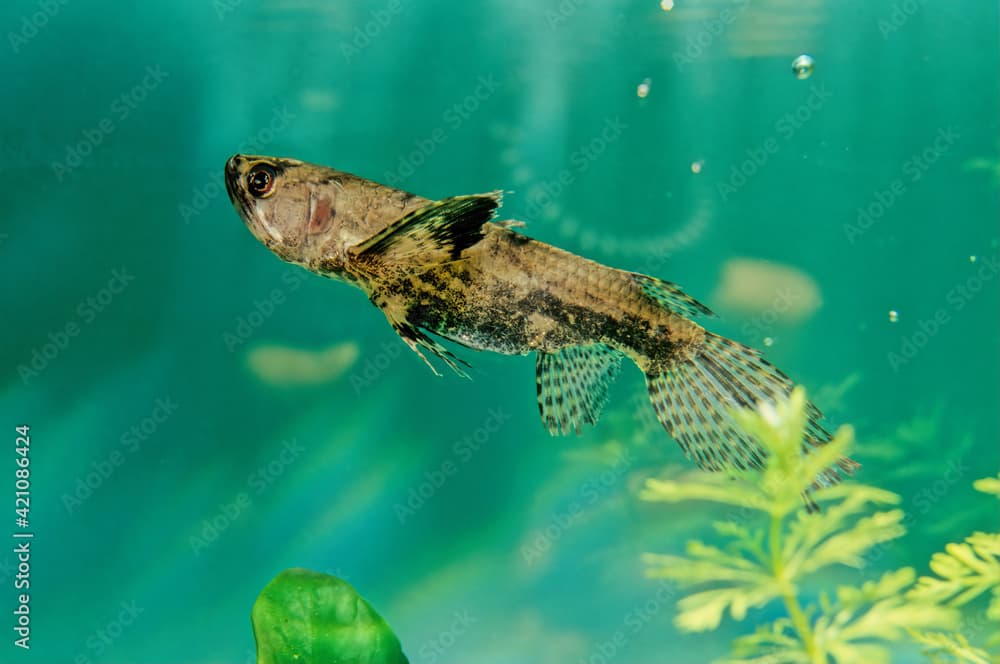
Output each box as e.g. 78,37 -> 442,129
225,154 -> 860,498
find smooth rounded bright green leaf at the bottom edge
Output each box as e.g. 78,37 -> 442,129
251,569 -> 408,664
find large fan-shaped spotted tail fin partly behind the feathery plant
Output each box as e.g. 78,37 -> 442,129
646,332 -> 859,508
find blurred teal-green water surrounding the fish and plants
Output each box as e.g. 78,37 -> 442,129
0,0 -> 1000,664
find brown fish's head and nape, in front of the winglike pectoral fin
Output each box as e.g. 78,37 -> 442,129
225,154 -> 428,277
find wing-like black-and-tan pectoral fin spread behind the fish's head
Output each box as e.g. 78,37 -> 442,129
351,191 -> 502,265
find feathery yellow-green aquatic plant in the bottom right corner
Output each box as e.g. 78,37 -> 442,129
641,388 -> 1000,664
